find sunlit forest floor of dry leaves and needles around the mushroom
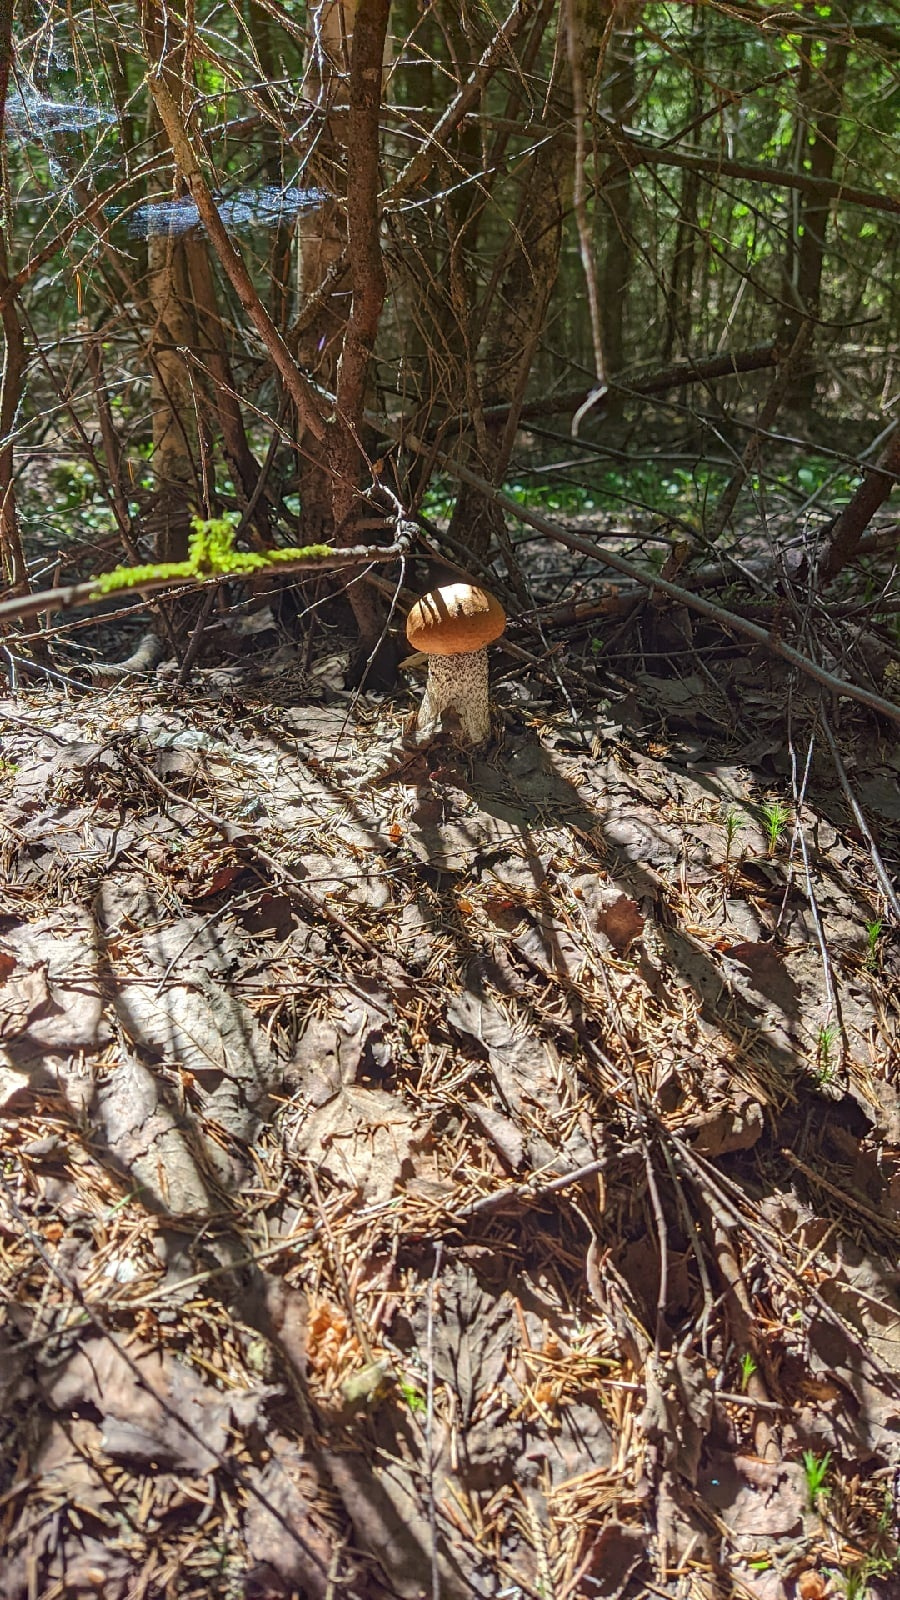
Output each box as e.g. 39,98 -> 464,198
0,582 -> 900,1600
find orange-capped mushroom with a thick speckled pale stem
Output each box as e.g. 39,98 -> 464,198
407,584 -> 506,744
